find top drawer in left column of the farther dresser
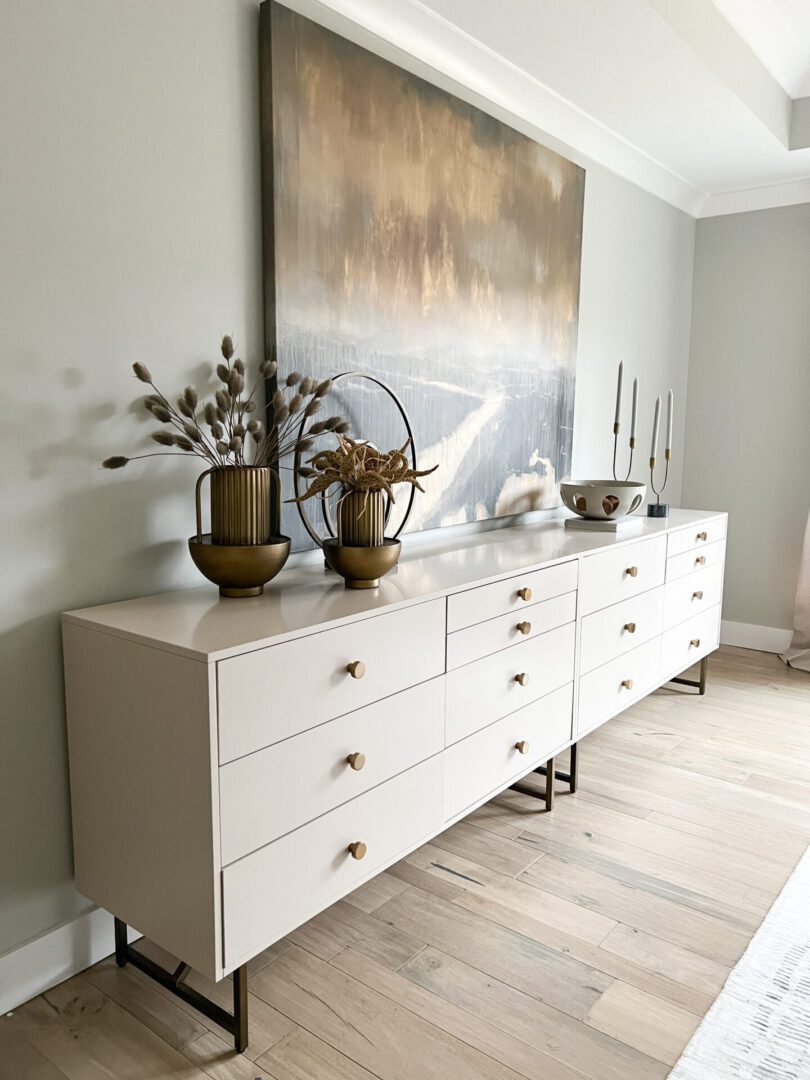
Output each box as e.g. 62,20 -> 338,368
579,536 -> 666,616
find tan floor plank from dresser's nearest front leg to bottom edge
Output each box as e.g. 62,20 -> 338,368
254,946 -> 527,1080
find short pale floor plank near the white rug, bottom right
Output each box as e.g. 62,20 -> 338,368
585,981 -> 700,1065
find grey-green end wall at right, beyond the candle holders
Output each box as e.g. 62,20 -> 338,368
684,204 -> 810,648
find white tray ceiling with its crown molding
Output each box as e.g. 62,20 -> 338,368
295,0 -> 810,216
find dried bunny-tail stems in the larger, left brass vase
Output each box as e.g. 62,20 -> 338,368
102,335 -> 350,469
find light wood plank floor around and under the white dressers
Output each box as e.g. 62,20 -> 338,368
0,648 -> 810,1080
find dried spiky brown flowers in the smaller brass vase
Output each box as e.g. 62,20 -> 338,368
289,431 -> 438,502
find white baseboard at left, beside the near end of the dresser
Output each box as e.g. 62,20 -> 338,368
0,907 -> 140,1016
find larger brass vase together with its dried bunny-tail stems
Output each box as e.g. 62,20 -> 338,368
103,335 -> 349,596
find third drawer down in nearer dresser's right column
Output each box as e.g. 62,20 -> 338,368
446,623 -> 575,745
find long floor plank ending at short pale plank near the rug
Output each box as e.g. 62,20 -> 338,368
376,888 -> 612,1020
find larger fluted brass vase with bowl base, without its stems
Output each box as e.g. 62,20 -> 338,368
188,465 -> 289,596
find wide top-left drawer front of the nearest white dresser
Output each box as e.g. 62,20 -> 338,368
217,600 -> 445,765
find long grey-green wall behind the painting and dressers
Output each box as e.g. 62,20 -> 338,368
0,0 -> 694,980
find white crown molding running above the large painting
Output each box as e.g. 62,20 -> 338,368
280,0 -> 706,217
